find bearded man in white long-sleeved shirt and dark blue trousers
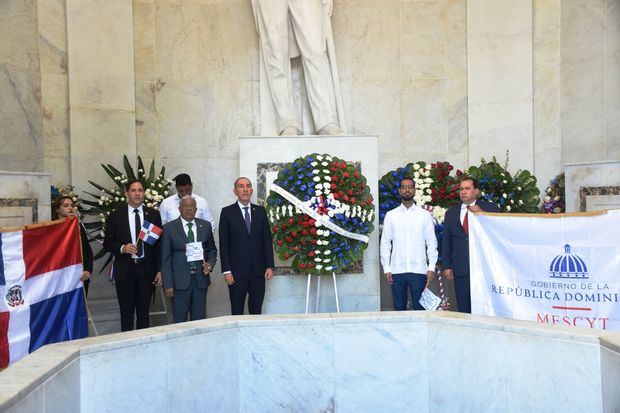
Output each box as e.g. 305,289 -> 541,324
380,177 -> 437,311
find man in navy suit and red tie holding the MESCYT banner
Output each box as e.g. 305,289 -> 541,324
441,178 -> 500,313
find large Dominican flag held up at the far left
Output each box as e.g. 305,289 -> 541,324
0,219 -> 88,368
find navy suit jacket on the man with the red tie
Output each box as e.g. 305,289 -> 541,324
441,199 -> 500,277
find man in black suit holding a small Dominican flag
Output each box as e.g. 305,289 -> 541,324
103,180 -> 161,331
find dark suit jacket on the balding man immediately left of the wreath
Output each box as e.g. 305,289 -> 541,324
219,202 -> 273,278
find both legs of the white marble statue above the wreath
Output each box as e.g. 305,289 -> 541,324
252,0 -> 344,135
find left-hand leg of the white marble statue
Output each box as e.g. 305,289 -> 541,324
254,0 -> 300,133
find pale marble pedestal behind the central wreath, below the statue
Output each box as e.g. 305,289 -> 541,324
239,136 -> 380,314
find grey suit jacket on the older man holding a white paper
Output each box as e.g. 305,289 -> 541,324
161,217 -> 217,290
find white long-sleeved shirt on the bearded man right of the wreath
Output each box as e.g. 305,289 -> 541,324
381,204 -> 438,274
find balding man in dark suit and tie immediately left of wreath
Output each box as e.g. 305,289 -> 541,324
219,177 -> 273,315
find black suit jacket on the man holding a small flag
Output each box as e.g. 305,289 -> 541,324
103,206 -> 162,281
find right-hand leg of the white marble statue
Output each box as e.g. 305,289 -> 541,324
289,0 -> 338,130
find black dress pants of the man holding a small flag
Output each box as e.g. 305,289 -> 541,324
115,261 -> 153,331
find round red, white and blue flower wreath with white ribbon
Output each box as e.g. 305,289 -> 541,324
267,153 -> 375,275
